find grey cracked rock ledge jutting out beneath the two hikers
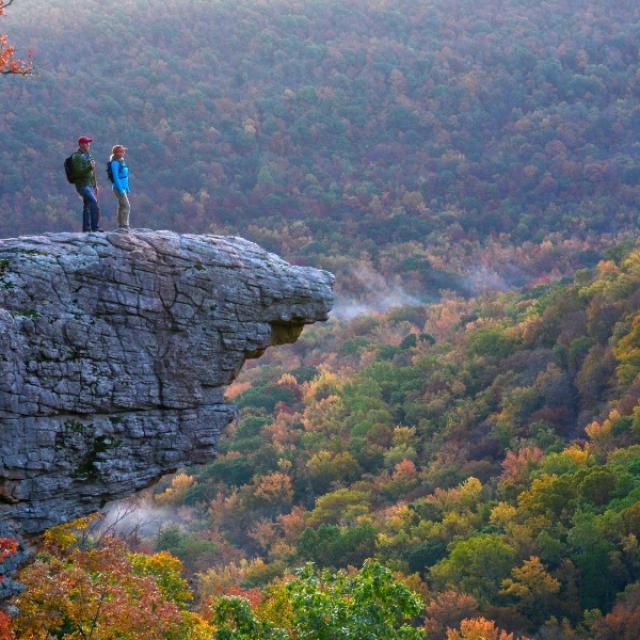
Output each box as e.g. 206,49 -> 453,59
0,230 -> 333,592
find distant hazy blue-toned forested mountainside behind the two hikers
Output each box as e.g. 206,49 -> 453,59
0,0 -> 640,295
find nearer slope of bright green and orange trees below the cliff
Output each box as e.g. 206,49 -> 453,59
18,241 -> 640,640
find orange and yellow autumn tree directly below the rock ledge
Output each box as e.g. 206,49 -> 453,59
12,518 -> 210,640
